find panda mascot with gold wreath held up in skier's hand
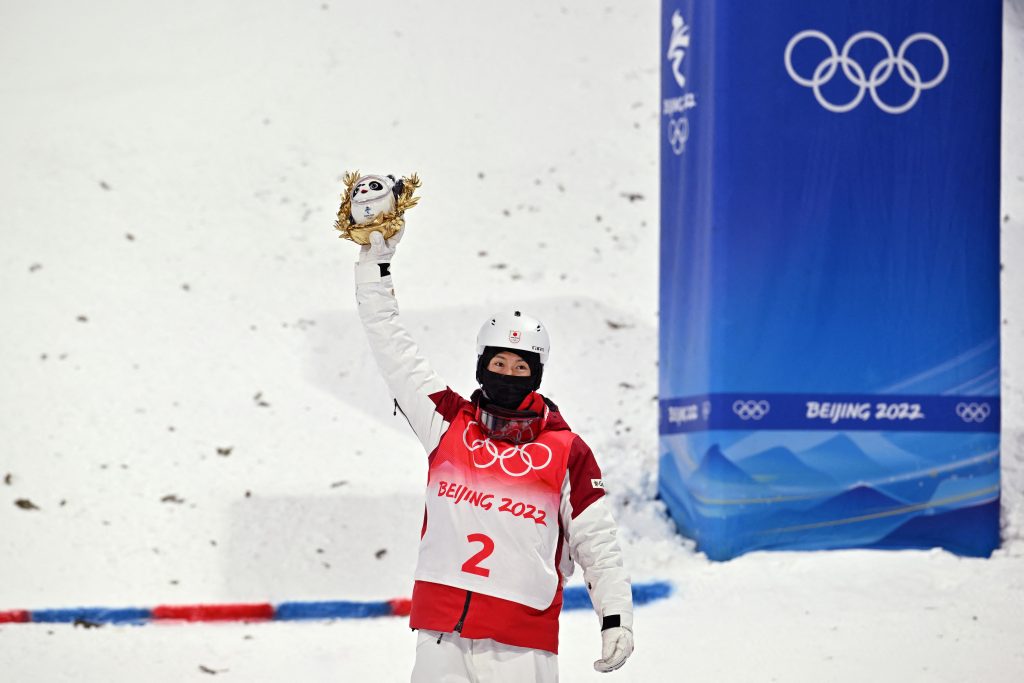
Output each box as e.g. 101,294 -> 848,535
334,171 -> 420,245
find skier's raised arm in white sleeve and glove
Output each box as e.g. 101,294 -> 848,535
355,232 -> 453,454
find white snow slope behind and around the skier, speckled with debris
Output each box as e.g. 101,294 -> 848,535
0,0 -> 1024,683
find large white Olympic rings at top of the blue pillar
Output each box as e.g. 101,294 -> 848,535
784,29 -> 949,114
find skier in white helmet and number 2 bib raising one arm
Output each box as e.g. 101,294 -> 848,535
355,225 -> 633,683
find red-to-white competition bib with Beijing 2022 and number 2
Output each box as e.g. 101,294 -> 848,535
416,410 -> 575,609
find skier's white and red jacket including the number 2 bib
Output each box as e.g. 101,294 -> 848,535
355,263 -> 633,652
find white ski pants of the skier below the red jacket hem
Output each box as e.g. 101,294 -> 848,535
412,631 -> 558,683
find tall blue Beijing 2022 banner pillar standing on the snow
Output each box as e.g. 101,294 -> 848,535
659,0 -> 1002,559
